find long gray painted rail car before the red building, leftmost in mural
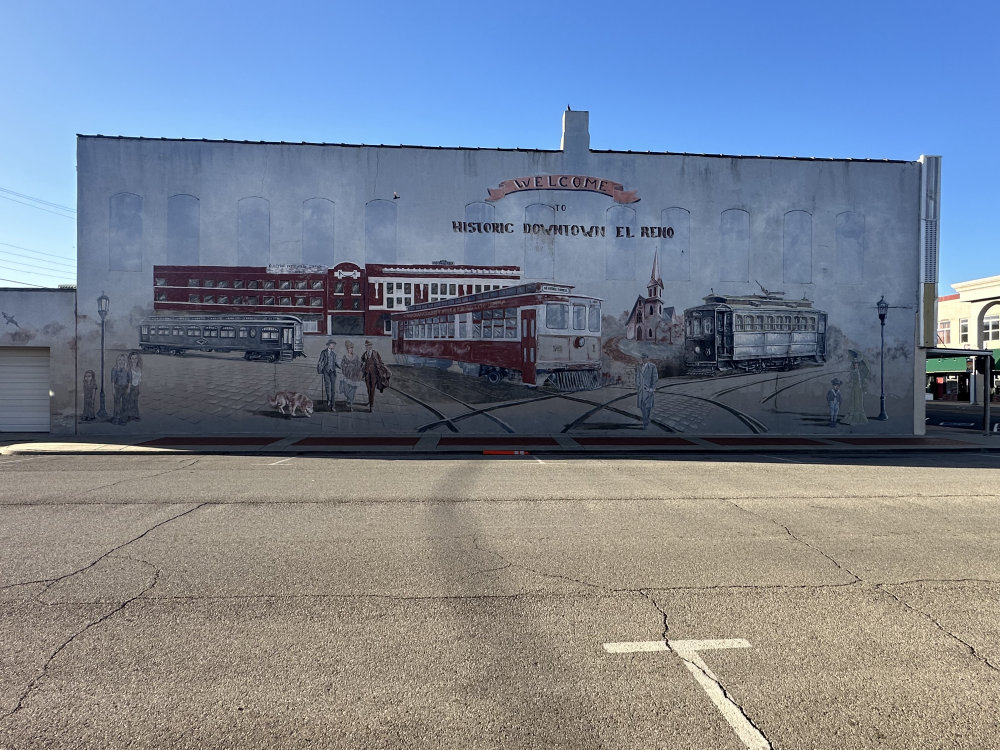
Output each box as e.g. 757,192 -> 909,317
139,315 -> 305,362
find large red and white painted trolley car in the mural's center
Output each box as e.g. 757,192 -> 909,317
392,282 -> 601,391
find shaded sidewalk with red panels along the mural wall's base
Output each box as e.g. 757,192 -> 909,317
0,426 -> 1000,456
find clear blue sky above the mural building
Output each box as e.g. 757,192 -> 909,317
0,0 -> 1000,293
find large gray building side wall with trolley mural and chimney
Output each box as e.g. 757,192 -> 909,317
4,111 -> 940,438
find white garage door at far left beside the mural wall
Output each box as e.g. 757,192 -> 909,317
0,347 -> 49,432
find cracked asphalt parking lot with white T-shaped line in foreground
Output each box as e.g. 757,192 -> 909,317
0,452 -> 1000,750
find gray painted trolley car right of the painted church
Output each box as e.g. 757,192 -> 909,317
684,289 -> 826,374
